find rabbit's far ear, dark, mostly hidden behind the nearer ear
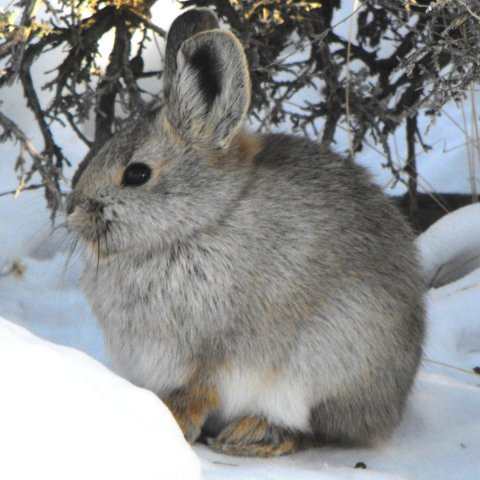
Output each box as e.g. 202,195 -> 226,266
163,8 -> 219,98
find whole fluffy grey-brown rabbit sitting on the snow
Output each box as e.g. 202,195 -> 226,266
67,9 -> 425,457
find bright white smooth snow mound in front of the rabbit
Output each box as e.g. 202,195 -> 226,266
0,318 -> 200,480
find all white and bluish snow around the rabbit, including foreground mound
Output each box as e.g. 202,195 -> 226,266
0,0 -> 480,480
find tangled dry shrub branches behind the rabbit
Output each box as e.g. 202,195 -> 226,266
0,0 -> 480,218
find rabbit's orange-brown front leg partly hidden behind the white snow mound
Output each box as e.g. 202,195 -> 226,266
164,387 -> 218,444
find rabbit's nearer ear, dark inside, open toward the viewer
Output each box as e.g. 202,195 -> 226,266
167,30 -> 251,149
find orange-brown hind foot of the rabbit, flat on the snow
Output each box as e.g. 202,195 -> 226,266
207,417 -> 300,457
